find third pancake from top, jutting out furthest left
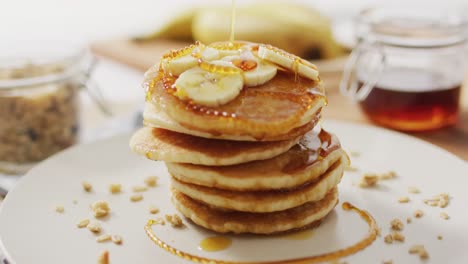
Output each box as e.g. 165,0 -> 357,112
130,127 -> 300,166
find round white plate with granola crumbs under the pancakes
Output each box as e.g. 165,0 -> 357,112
0,121 -> 468,264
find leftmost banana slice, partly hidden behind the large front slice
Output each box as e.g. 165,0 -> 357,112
161,47 -> 219,76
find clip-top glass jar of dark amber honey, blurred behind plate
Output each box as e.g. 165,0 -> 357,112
340,8 -> 468,131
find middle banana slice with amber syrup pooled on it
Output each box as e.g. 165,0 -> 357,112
221,52 -> 278,87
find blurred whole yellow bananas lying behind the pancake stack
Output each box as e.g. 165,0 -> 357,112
137,2 -> 345,59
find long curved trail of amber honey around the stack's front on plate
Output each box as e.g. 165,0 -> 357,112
145,202 -> 378,264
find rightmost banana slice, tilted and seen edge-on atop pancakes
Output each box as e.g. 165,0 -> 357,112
258,45 -> 319,81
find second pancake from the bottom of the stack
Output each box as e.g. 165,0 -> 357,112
172,156 -> 347,213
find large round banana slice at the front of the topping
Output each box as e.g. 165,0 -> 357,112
174,61 -> 244,107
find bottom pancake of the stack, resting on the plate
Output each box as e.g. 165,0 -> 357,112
172,188 -> 338,234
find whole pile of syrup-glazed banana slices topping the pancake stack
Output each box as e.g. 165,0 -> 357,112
161,42 -> 319,107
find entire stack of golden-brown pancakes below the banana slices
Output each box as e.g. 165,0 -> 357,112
130,46 -> 349,234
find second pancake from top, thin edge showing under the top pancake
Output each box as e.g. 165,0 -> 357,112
143,103 -> 321,141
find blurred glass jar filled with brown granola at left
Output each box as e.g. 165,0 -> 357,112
0,52 -> 103,174
